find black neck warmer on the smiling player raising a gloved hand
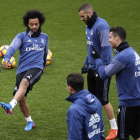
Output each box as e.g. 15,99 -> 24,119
114,41 -> 129,54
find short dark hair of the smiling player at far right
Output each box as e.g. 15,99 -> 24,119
110,26 -> 126,41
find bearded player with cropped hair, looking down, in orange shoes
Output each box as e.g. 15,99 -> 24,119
79,3 -> 118,140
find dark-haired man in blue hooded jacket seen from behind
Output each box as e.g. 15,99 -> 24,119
66,73 -> 105,140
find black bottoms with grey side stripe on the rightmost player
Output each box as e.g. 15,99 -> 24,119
117,106 -> 140,140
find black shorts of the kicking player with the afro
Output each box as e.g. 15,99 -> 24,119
13,68 -> 43,96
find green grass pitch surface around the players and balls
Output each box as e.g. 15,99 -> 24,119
0,0 -> 140,140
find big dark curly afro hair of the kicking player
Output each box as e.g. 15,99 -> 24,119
22,9 -> 46,27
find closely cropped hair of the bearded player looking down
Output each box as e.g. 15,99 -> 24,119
78,3 -> 94,13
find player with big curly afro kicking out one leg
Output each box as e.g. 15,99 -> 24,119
1,10 -> 48,131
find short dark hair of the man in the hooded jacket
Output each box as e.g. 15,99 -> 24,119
67,73 -> 84,92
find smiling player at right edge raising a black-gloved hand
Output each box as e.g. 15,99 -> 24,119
92,26 -> 140,140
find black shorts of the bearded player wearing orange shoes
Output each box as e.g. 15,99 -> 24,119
87,69 -> 111,106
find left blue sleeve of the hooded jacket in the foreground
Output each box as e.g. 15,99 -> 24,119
67,108 -> 84,140
